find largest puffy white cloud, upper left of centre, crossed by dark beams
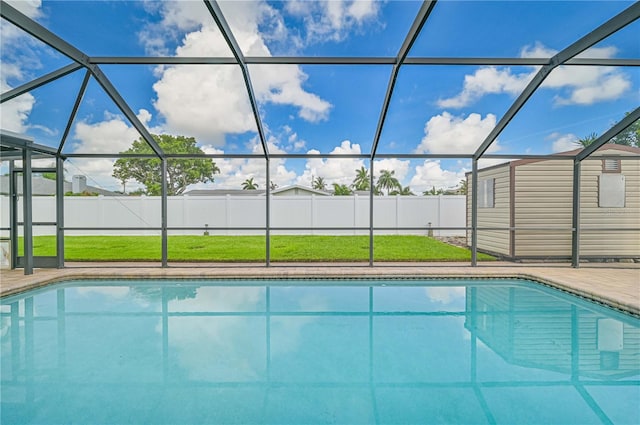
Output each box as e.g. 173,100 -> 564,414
142,2 -> 331,146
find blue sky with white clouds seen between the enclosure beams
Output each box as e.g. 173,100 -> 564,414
0,0 -> 640,193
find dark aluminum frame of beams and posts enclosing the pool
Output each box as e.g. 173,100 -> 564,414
0,0 -> 640,273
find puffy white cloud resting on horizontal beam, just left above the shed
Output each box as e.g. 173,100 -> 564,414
416,111 -> 500,154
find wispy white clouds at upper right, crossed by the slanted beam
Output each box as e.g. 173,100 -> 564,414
437,43 -> 631,108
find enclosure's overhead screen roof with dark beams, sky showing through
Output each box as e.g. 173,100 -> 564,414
0,0 -> 640,190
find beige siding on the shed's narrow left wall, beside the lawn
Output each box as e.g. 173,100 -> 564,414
467,164 -> 510,255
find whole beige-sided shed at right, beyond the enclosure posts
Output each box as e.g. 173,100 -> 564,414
467,143 -> 640,260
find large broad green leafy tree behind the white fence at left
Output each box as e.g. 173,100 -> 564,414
113,134 -> 220,196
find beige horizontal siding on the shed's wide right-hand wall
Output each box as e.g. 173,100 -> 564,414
514,152 -> 640,257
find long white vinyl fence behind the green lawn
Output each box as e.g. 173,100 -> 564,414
0,195 -> 466,236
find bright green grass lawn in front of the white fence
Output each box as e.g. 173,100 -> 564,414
19,235 -> 494,262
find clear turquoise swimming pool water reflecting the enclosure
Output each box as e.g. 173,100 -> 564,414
0,279 -> 640,424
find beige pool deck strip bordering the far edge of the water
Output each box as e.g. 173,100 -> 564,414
0,262 -> 640,316
